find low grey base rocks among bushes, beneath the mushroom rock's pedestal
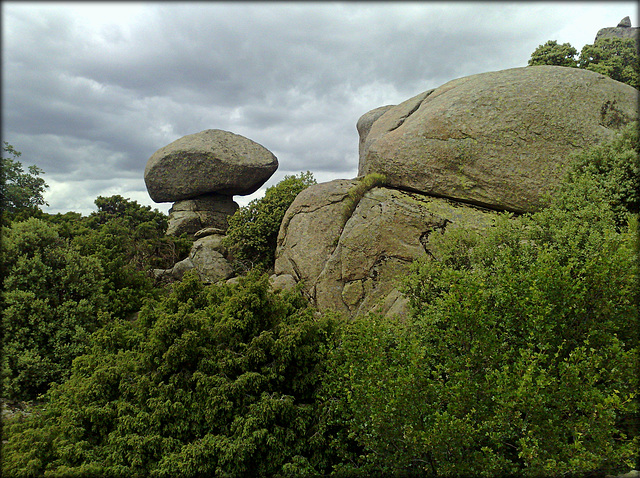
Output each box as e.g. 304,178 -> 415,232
154,234 -> 233,283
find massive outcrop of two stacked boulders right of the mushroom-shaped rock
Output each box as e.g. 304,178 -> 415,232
272,66 -> 638,317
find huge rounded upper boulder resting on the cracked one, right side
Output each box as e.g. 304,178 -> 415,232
358,66 -> 638,212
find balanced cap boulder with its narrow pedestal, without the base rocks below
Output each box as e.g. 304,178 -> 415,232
144,129 -> 278,236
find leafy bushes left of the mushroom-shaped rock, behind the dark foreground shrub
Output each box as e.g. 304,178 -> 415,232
1,196 -> 188,400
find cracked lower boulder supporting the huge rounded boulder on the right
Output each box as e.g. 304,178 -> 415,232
275,180 -> 496,316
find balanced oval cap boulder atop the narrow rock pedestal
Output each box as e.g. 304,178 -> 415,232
144,129 -> 278,202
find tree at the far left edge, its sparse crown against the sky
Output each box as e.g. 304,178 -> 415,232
0,141 -> 49,220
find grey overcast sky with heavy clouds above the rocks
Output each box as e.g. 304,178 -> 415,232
2,1 -> 638,214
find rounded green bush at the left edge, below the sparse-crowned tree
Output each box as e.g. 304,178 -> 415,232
2,218 -> 108,399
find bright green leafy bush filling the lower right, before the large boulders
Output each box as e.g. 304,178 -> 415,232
322,129 -> 640,476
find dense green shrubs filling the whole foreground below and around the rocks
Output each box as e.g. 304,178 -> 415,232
1,130 -> 640,477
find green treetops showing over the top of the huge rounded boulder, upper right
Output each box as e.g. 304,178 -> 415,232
528,38 -> 640,89
